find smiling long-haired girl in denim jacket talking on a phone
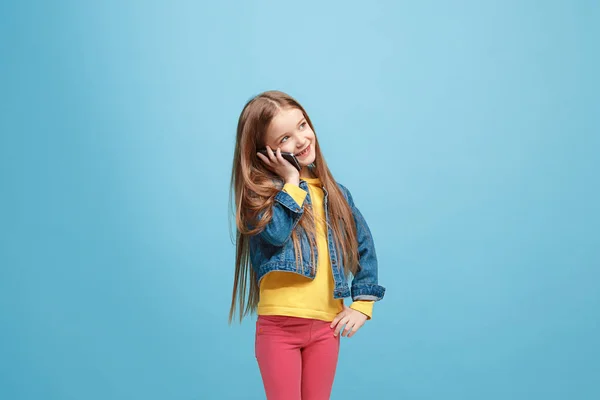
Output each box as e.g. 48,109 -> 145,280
229,91 -> 385,400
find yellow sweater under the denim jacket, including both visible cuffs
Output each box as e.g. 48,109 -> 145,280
257,178 -> 374,321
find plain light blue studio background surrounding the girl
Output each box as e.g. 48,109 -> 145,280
0,0 -> 600,400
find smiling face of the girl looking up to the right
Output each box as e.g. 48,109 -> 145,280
265,108 -> 316,166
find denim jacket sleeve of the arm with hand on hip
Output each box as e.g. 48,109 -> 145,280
340,185 -> 385,301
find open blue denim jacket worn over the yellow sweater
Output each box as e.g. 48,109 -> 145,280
250,180 -> 385,301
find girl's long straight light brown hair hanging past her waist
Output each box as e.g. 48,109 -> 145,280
229,91 -> 358,323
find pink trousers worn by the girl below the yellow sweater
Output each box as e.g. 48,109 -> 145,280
255,315 -> 340,400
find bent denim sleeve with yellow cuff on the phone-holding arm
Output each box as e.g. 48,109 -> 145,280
258,184 -> 308,247
